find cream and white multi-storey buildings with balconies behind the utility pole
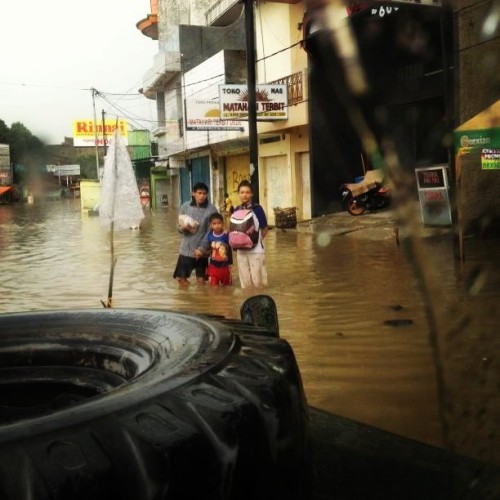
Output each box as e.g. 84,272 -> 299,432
137,0 -> 311,223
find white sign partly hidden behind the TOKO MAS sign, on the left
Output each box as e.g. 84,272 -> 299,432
186,99 -> 244,132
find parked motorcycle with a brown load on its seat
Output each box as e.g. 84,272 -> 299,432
341,170 -> 391,215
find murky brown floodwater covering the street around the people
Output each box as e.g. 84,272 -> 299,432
0,200 -> 500,463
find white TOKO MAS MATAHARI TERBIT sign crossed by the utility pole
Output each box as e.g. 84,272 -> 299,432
219,85 -> 288,121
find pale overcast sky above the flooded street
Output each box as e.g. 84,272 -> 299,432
0,0 -> 158,144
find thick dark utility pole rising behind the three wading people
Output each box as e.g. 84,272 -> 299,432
244,0 -> 259,203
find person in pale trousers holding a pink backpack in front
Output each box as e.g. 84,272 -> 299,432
231,179 -> 269,288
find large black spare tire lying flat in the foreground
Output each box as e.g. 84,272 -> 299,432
0,309 -> 309,500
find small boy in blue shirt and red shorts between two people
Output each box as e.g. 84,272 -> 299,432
207,213 -> 233,286
